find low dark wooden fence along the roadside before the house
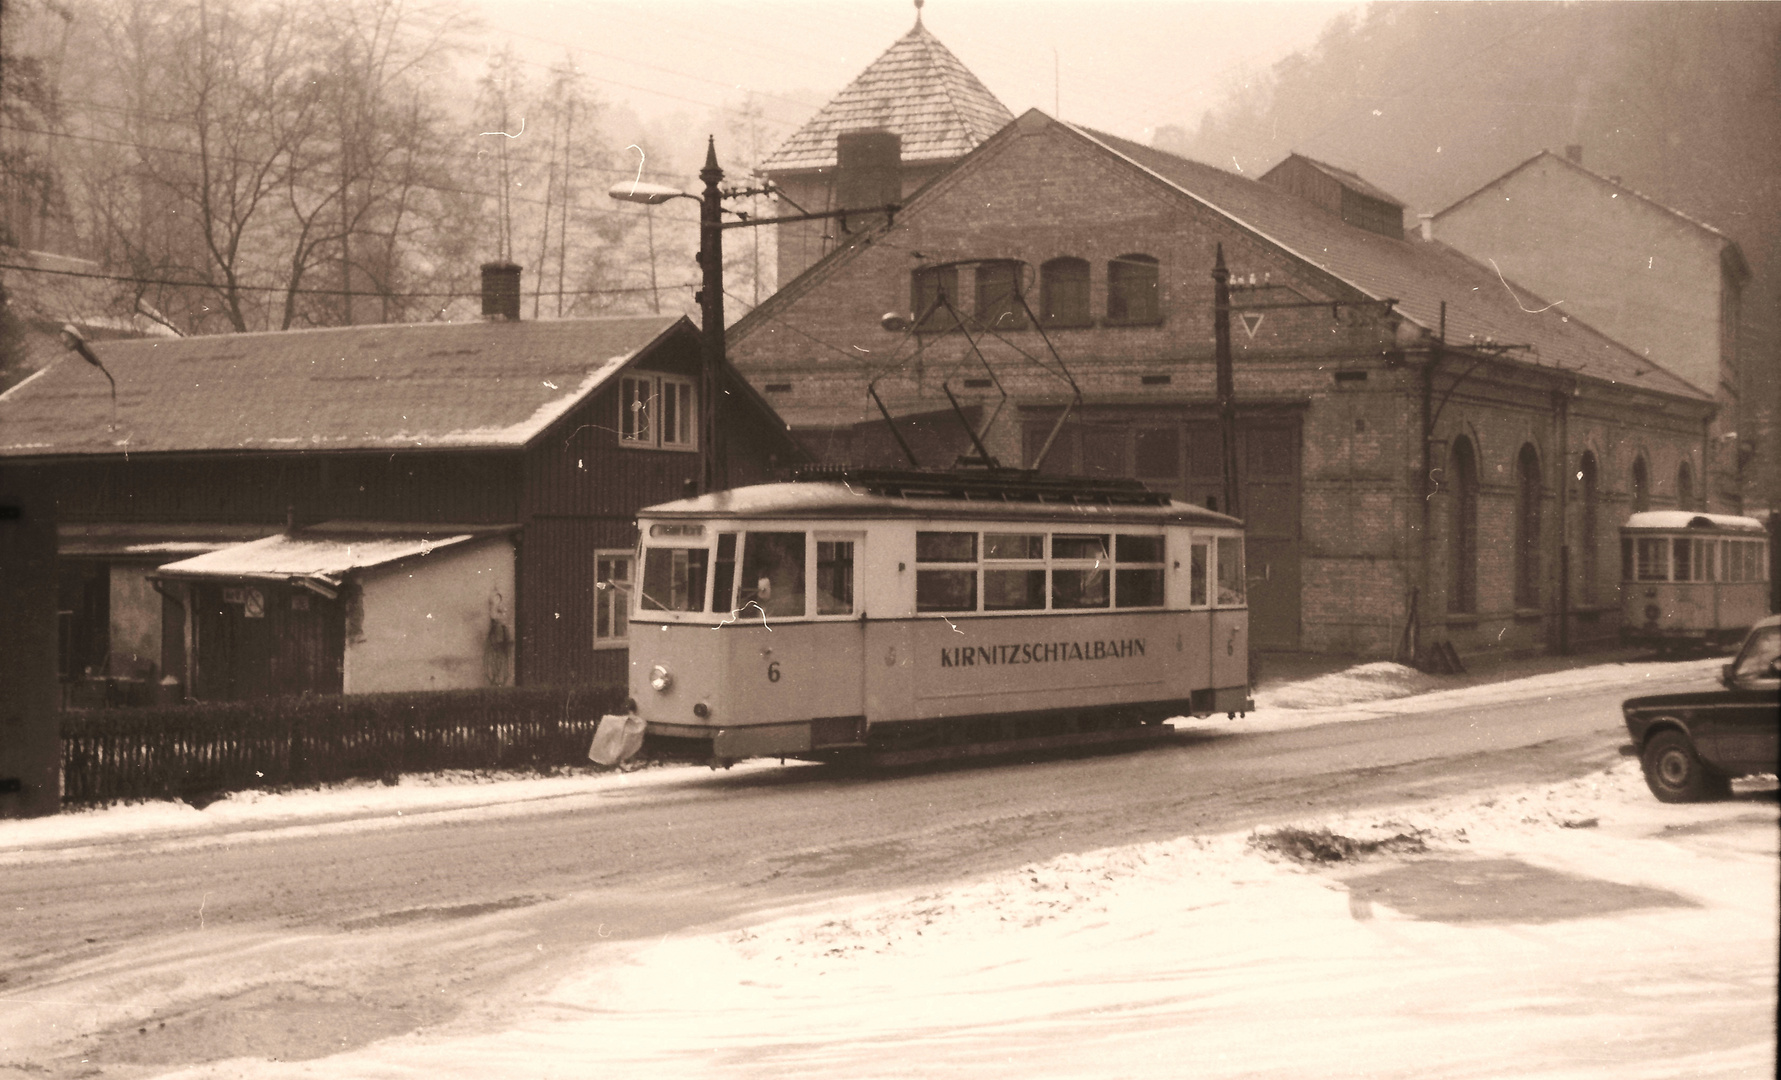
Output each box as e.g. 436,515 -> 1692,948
62,686 -> 625,804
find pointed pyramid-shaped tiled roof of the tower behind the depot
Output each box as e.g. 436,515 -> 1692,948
759,20 -> 1013,173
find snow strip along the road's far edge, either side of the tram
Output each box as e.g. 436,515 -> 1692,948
0,659 -> 1720,866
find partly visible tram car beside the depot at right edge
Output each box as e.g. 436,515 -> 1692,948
1621,510 -> 1769,652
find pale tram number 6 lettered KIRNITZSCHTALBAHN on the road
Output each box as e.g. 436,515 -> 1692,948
627,470 -> 1254,763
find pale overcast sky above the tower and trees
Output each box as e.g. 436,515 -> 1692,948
476,0 -> 1361,150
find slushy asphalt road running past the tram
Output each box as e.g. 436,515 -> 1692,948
0,690 -> 1695,1076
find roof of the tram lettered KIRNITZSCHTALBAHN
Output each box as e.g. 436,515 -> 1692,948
638,478 -> 1243,529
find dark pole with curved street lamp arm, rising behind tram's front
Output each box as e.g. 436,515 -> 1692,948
606,135 -> 901,494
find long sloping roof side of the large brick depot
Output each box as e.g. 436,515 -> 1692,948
1072,125 -> 1708,399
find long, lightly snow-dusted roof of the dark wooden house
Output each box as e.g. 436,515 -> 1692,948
0,315 -> 696,458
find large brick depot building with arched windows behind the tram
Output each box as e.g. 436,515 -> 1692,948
730,110 -> 1719,656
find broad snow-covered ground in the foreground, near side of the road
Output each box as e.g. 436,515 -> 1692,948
146,761 -> 1777,1080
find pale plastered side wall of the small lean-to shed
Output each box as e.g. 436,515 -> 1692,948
342,536 -> 513,693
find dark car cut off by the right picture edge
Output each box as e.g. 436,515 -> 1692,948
1621,615 -> 1781,802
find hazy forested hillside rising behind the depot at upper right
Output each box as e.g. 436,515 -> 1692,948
1156,2 -> 1781,497
